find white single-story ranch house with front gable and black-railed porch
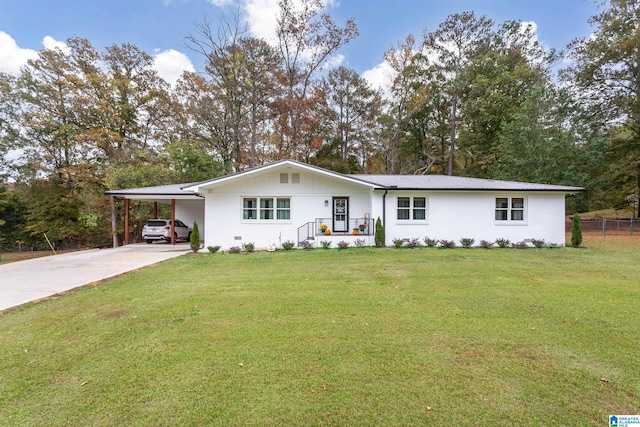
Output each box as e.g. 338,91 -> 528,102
107,160 -> 583,250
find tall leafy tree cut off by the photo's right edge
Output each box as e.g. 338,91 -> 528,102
563,0 -> 640,217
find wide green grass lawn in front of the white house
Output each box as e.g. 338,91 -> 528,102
0,238 -> 640,426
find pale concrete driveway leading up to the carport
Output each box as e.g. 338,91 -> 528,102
0,243 -> 190,311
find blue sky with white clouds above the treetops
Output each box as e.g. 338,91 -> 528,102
0,0 -> 597,86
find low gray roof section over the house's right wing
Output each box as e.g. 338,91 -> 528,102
348,174 -> 584,193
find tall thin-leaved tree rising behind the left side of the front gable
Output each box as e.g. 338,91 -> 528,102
181,16 -> 280,172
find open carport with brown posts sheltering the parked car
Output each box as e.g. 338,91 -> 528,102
105,184 -> 204,247
